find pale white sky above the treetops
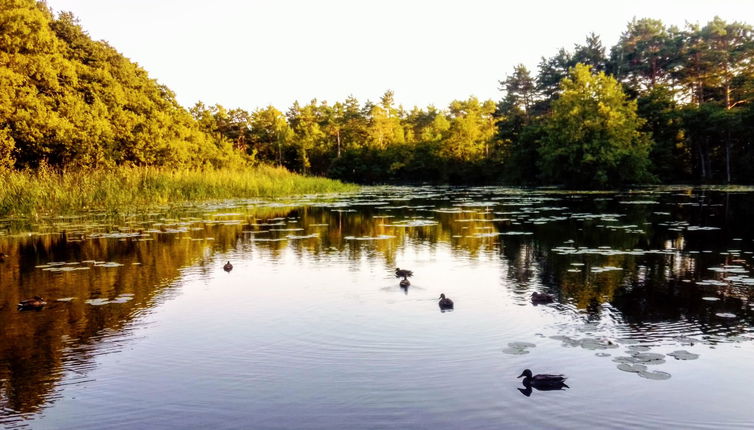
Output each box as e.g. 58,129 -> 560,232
47,0 -> 754,111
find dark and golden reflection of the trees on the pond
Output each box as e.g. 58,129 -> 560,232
0,187 -> 754,425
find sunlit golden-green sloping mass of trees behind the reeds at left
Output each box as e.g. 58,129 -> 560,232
0,0 -> 241,167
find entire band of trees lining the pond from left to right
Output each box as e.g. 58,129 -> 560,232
0,0 -> 754,187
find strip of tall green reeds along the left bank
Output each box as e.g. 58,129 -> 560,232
0,166 -> 356,217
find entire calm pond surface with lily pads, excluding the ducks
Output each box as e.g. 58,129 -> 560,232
0,188 -> 754,429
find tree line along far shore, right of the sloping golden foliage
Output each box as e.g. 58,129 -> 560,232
192,18 -> 754,187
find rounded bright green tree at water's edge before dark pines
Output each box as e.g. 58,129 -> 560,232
539,64 -> 651,187
